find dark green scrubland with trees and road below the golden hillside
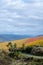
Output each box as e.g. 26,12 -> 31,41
0,42 -> 43,65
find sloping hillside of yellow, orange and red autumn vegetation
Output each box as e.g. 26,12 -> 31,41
0,36 -> 43,50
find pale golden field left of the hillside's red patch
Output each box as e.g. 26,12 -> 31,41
0,39 -> 27,50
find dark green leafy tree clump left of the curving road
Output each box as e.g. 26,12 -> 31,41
8,42 -> 20,58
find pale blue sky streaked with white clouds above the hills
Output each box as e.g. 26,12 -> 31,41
0,0 -> 43,35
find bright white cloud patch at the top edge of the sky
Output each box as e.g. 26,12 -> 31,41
5,0 -> 26,9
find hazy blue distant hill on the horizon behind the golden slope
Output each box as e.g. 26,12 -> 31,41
0,34 -> 34,42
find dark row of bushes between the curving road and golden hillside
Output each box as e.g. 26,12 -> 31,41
20,44 -> 43,56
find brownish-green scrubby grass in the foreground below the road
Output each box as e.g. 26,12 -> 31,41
0,54 -> 43,65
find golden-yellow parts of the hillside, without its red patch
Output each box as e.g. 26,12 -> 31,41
0,37 -> 43,50
